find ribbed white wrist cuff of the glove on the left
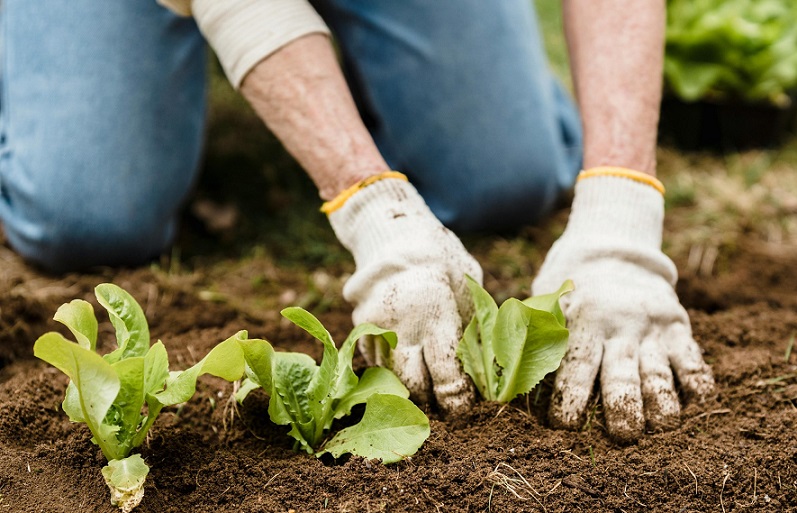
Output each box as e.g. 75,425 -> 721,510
328,177 -> 443,265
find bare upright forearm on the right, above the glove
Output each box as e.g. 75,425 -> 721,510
563,0 -> 665,176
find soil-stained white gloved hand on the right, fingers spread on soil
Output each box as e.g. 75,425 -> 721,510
532,168 -> 714,442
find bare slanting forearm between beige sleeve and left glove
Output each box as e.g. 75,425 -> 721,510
241,34 -> 388,200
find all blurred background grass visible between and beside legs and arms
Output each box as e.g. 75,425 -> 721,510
177,0 -> 797,300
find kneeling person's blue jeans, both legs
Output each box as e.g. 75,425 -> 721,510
0,0 -> 581,271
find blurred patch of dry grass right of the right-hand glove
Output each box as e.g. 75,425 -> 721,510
659,139 -> 797,274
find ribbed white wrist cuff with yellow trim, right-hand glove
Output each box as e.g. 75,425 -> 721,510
567,168 -> 664,249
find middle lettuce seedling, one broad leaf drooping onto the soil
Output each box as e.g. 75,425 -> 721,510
237,307 -> 429,463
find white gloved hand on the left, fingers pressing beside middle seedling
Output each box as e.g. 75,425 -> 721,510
326,173 -> 482,413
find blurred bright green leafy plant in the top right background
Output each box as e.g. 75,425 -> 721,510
664,0 -> 797,105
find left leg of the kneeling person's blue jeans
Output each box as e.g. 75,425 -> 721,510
0,0 -> 206,271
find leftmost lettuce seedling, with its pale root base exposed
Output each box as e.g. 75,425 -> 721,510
33,283 -> 246,512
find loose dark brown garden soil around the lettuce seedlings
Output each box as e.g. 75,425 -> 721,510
0,230 -> 797,513
